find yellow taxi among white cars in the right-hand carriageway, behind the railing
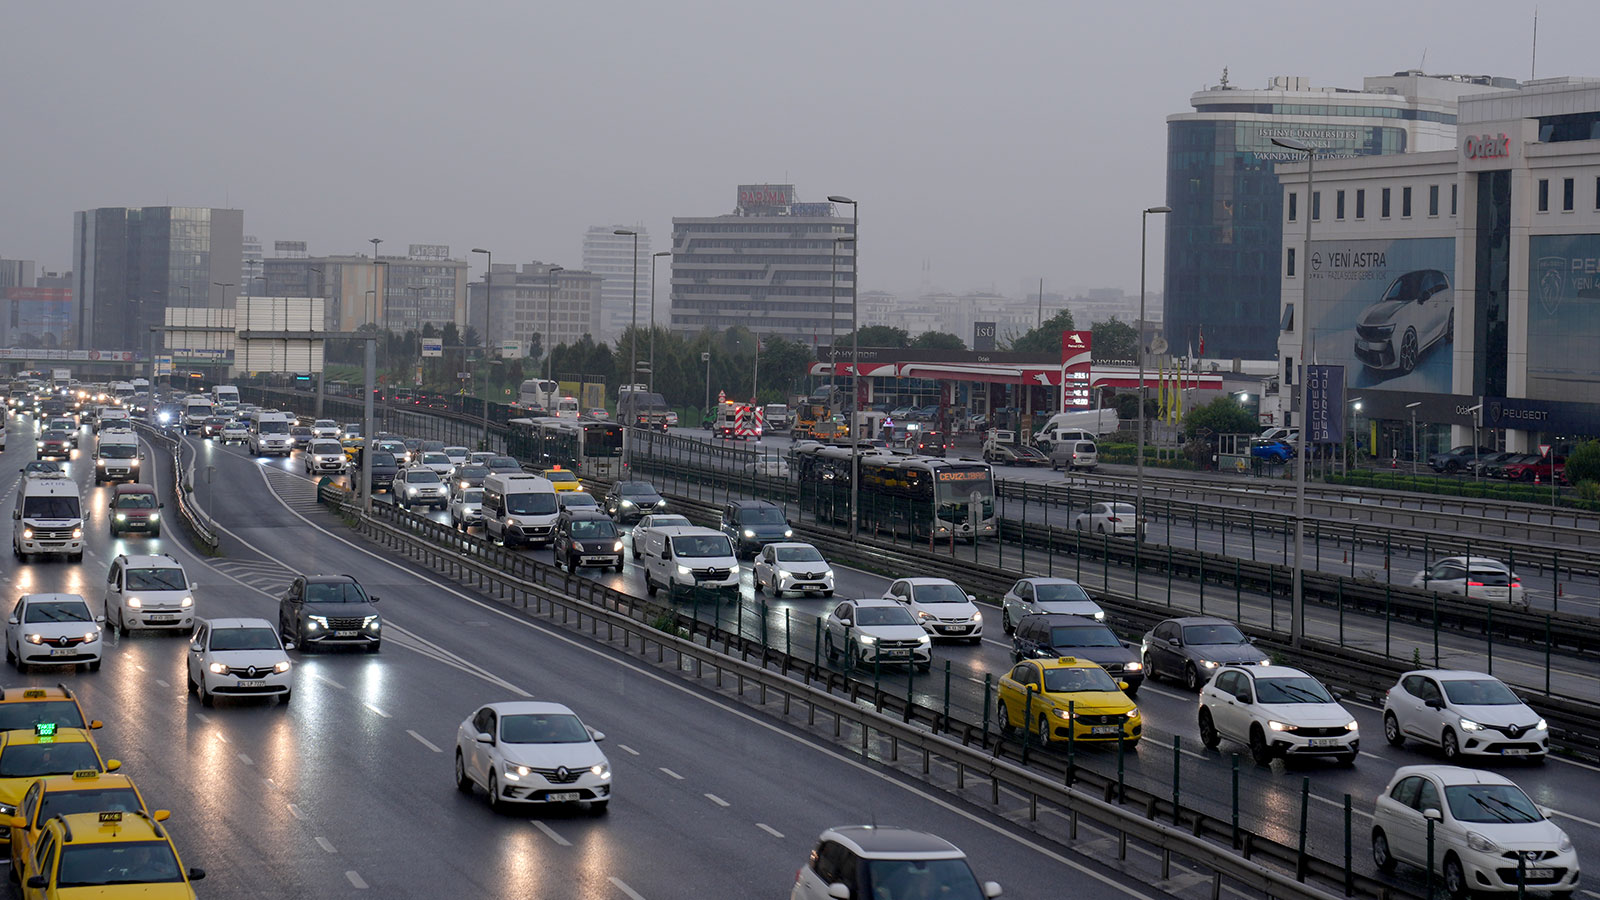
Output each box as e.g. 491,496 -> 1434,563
998,657 -> 1144,749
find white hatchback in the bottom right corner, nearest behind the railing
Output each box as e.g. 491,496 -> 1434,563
1373,765 -> 1579,898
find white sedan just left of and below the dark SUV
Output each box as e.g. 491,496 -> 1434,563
187,618 -> 294,706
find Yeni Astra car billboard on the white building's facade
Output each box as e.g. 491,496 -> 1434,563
1307,237 -> 1456,394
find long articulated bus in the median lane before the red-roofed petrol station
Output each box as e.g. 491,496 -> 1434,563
794,444 -> 998,540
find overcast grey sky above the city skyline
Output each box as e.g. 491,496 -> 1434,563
0,0 -> 1600,293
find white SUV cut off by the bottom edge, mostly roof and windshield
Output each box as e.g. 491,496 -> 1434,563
789,825 -> 1000,900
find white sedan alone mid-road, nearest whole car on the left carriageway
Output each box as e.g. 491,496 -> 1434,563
456,700 -> 613,815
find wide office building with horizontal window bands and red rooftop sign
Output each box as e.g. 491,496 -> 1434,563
670,184 -> 856,343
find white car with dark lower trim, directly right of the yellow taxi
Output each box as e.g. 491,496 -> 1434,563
1200,666 -> 1362,765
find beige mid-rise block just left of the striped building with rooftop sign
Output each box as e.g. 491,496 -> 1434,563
467,261 -> 605,352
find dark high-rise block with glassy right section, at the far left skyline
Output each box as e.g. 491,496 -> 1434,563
64,207 -> 245,349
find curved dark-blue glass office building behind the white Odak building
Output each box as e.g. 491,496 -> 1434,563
1152,70 -> 1515,359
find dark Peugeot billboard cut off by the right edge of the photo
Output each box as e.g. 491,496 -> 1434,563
1526,234 -> 1600,404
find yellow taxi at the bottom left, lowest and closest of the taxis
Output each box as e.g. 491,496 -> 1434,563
16,810 -> 205,900
